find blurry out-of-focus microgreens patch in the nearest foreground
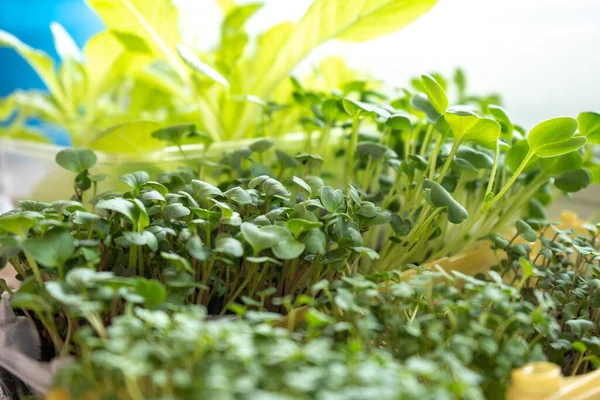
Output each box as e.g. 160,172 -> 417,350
57,307 -> 477,400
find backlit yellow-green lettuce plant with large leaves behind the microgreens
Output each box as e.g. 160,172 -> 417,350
0,0 -> 436,147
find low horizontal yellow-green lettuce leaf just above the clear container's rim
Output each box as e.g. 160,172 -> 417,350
90,121 -> 164,154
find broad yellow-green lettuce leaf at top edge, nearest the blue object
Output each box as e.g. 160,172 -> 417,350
87,0 -> 188,78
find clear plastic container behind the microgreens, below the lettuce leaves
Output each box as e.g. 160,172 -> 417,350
0,133 -> 316,205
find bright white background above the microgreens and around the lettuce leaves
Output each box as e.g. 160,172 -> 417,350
176,0 -> 600,127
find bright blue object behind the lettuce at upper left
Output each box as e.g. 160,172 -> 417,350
0,0 -> 103,145
